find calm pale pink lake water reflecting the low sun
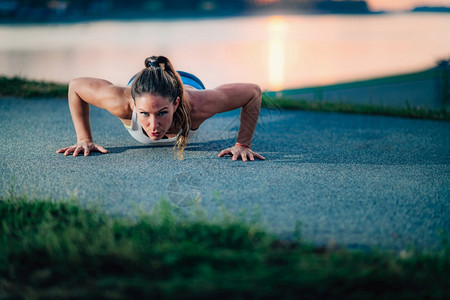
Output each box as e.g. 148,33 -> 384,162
0,14 -> 450,90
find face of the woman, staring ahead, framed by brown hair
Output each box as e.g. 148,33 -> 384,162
135,94 -> 180,140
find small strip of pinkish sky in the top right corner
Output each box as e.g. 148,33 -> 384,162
366,0 -> 450,11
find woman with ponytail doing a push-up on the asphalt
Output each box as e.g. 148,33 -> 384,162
57,56 -> 264,161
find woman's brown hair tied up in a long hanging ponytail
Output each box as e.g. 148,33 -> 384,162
131,56 -> 191,160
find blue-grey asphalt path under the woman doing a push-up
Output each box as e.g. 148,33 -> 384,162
0,99 -> 450,249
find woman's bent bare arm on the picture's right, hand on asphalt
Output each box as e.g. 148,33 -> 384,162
196,83 -> 265,161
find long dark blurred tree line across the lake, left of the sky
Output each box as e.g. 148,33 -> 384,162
0,0 -> 370,21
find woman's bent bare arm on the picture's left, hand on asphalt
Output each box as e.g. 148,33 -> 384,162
56,78 -> 131,156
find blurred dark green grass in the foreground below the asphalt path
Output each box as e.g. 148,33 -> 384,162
0,196 -> 450,299
